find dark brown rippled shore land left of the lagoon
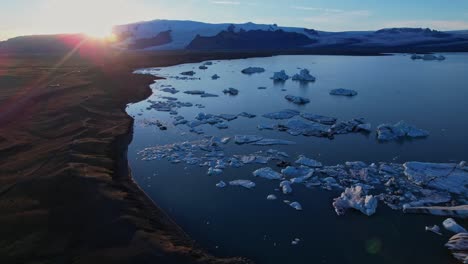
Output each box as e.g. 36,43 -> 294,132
0,44 -> 266,263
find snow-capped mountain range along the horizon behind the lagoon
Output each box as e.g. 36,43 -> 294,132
0,20 -> 468,54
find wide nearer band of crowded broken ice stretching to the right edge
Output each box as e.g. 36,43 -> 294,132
139,135 -> 468,217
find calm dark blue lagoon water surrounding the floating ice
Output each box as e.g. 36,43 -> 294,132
127,54 -> 468,263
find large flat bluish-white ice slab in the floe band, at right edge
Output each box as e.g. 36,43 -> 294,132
403,161 -> 468,196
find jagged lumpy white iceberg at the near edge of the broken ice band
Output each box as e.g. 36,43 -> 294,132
333,185 -> 378,216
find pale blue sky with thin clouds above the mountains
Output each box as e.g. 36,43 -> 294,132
0,0 -> 468,40
